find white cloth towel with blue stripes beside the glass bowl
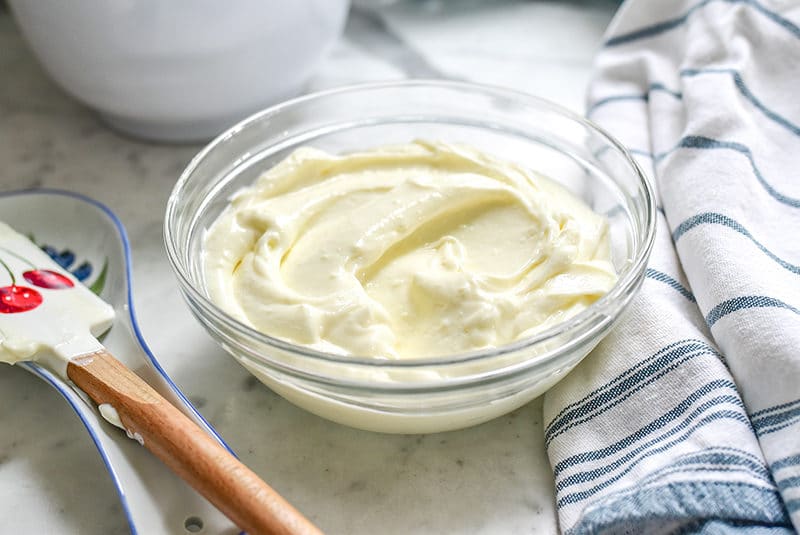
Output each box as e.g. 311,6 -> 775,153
545,0 -> 800,534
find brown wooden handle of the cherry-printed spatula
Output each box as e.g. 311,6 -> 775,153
67,351 -> 322,535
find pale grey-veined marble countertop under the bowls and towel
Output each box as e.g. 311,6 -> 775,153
0,0 -> 616,535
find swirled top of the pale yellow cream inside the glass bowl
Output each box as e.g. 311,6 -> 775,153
204,142 -> 616,359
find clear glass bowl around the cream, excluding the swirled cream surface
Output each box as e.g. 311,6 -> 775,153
164,81 -> 655,433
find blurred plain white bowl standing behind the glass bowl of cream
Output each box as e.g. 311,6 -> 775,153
9,0 -> 350,141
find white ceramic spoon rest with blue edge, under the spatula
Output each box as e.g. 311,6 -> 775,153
0,189 -> 239,535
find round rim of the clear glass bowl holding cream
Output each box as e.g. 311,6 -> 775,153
163,79 -> 657,369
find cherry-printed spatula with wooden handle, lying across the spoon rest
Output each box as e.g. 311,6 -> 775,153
0,222 -> 321,535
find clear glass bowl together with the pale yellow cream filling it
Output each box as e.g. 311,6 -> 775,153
164,81 -> 655,433
